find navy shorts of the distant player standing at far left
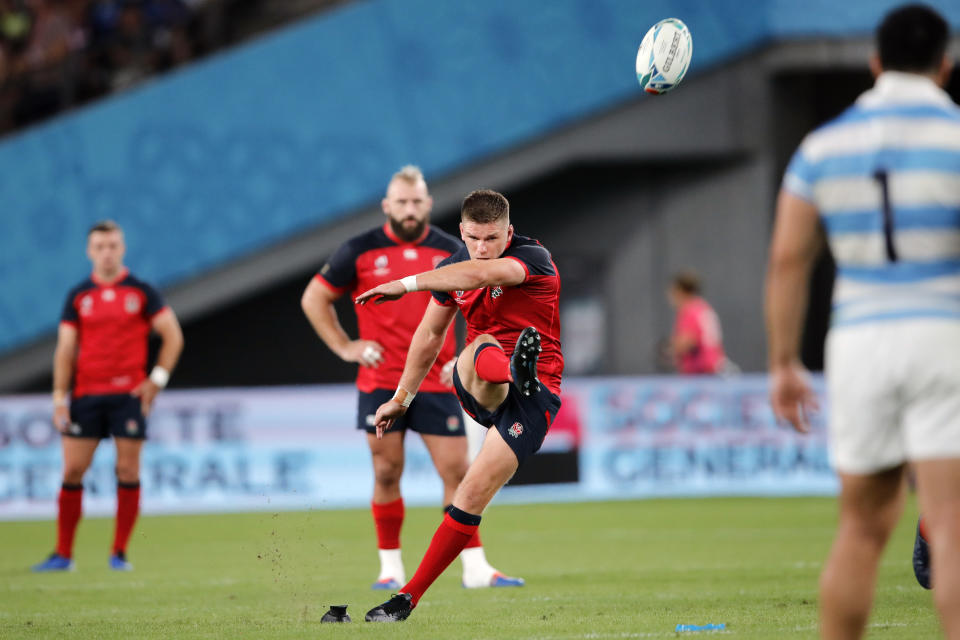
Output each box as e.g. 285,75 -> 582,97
66,393 -> 147,440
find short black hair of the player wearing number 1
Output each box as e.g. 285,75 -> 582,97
877,4 -> 950,73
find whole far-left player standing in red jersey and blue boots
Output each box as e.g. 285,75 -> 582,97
33,220 -> 183,571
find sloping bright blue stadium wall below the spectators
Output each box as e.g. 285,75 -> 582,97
0,0 -> 960,354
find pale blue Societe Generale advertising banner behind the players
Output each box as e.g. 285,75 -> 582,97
0,376 -> 837,519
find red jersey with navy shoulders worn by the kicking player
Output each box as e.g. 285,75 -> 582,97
433,234 -> 563,395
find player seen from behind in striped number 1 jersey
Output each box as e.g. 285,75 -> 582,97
766,5 -> 960,638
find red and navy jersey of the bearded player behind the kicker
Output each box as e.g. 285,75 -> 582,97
316,223 -> 463,393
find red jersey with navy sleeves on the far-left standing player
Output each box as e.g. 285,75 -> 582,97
60,269 -> 164,398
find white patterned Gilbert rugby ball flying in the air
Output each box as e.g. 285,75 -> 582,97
637,18 -> 693,95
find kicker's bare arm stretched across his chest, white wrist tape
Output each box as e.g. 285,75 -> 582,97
357,258 -> 527,304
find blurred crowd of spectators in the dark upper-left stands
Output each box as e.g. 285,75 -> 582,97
0,0 -> 216,133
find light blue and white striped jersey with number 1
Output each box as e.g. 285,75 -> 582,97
783,71 -> 960,326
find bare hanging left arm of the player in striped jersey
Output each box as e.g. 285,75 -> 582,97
766,191 -> 822,431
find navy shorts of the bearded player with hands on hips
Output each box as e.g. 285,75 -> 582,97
357,389 -> 467,436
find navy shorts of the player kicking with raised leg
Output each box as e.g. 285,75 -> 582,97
453,367 -> 560,464
